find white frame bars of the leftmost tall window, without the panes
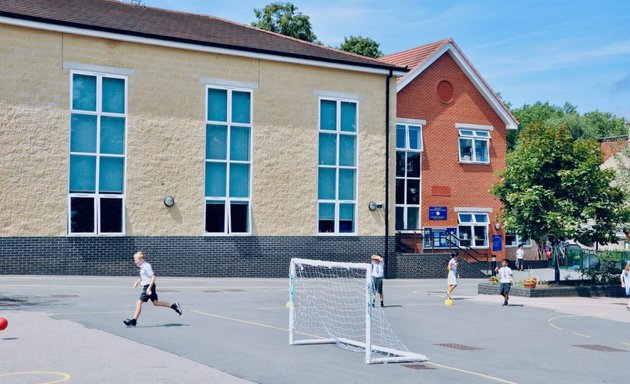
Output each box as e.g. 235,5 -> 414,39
67,67 -> 129,237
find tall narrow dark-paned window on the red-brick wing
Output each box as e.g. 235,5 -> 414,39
396,123 -> 422,231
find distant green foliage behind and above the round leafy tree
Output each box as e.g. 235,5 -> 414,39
508,101 -> 627,151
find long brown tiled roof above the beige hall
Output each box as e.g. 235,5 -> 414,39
0,0 -> 403,71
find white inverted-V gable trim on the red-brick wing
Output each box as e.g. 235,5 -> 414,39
396,43 -> 518,129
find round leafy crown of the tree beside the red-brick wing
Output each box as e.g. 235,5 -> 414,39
492,123 -> 628,248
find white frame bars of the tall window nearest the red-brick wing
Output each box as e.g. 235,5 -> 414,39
315,94 -> 361,236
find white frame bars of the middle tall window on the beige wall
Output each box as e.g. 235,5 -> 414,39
202,83 -> 254,236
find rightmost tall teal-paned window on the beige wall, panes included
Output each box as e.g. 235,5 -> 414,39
317,98 -> 358,233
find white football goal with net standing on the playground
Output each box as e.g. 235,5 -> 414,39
289,259 -> 427,364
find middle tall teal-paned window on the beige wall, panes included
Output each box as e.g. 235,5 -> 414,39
205,87 -> 252,234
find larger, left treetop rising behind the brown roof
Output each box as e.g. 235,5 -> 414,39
252,2 -> 317,43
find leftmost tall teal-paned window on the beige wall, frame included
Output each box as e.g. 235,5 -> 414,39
68,71 -> 127,235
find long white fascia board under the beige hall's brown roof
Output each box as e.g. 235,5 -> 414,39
0,16 -> 406,77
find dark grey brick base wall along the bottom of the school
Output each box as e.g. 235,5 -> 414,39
0,236 -> 483,278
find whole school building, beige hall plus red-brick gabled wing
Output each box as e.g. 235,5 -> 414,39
0,0 -> 517,277
